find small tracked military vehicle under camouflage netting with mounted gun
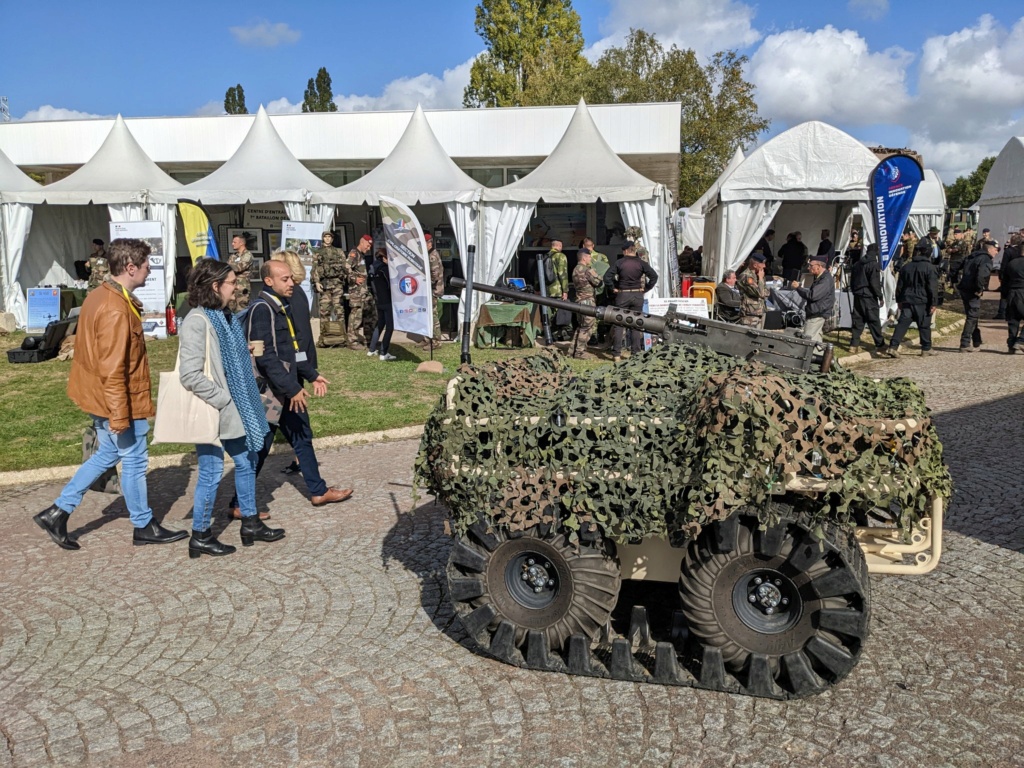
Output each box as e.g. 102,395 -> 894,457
416,286 -> 951,698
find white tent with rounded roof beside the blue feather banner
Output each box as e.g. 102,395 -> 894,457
703,122 -> 879,280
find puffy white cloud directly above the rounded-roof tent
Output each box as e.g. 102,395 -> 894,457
749,25 -> 912,125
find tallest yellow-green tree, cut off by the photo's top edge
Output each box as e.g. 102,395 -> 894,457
463,0 -> 590,106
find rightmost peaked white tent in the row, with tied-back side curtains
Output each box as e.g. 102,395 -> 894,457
476,99 -> 676,311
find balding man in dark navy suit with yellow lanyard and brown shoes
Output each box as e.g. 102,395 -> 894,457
245,261 -> 352,507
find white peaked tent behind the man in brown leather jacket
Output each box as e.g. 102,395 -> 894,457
2,115 -> 181,326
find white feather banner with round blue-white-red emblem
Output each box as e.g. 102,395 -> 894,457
380,195 -> 434,338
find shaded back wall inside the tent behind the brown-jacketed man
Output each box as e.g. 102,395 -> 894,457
17,205 -> 111,289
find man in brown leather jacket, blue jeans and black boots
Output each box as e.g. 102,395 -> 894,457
32,240 -> 188,550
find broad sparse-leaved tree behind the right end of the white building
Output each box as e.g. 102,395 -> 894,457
585,30 -> 769,206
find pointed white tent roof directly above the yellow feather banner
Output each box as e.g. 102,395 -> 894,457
178,105 -> 334,205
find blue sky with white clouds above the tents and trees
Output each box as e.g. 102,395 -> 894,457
0,0 -> 1024,182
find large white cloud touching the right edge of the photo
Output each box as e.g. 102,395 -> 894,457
908,14 -> 1024,182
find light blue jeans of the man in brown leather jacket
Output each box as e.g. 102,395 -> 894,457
53,416 -> 153,528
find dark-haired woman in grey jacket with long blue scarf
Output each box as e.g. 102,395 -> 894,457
178,259 -> 285,558
